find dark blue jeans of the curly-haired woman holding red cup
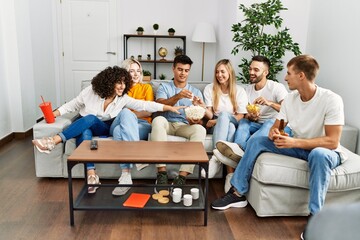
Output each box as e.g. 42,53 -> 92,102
59,114 -> 112,170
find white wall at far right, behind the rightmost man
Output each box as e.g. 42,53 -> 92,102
307,0 -> 360,152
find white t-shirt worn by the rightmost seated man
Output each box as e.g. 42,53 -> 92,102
277,86 -> 346,160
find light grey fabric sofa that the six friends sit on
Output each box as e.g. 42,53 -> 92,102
33,80 -> 360,216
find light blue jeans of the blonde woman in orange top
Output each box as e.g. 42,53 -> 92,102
110,108 -> 140,169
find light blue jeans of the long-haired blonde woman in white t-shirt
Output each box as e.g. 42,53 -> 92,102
213,112 -> 238,149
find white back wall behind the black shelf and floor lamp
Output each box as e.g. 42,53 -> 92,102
118,0 -> 219,81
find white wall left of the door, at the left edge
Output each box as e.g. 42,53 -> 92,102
0,0 -> 57,138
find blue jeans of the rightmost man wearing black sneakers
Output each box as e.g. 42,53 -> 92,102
231,136 -> 341,214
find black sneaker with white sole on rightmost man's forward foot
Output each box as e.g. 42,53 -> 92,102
211,187 -> 247,210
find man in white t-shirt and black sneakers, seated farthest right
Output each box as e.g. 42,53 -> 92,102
211,55 -> 346,239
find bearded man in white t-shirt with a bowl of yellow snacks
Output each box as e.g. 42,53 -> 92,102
214,56 -> 290,192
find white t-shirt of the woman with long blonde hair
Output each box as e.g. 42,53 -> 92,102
204,83 -> 248,116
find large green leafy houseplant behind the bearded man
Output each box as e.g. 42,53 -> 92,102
231,0 -> 301,83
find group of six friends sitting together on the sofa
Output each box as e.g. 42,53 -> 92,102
33,55 -> 346,239
